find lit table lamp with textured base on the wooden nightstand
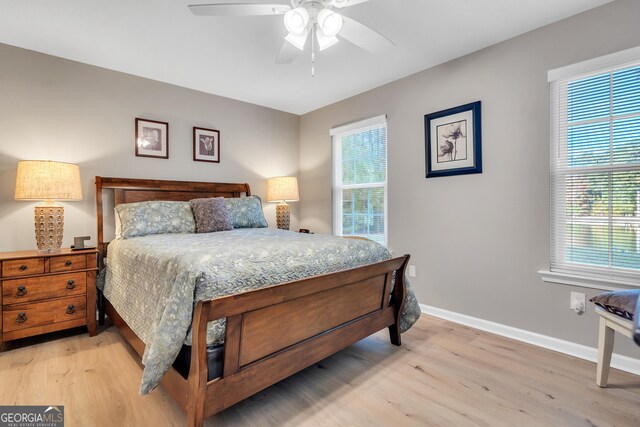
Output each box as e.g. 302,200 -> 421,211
15,160 -> 82,252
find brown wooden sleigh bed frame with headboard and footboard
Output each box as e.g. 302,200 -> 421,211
95,176 -> 409,426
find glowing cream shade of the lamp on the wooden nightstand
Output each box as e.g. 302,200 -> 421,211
15,160 -> 82,200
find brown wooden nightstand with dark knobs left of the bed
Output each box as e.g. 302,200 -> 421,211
0,249 -> 98,348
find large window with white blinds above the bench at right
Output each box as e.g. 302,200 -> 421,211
549,49 -> 640,281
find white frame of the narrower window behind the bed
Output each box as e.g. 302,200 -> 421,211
329,115 -> 389,247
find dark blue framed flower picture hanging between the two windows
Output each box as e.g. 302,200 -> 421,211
424,101 -> 482,178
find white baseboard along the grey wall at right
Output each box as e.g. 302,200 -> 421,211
420,304 -> 640,375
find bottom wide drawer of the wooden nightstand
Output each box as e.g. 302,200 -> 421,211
2,296 -> 87,332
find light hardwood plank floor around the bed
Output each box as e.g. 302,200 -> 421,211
0,316 -> 640,427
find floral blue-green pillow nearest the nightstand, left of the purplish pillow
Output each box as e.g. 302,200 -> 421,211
116,201 -> 196,239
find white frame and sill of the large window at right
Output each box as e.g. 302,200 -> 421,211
538,46 -> 640,290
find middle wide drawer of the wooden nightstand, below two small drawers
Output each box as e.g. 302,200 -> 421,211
2,272 -> 87,305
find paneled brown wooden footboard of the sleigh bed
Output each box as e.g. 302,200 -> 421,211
187,255 -> 409,426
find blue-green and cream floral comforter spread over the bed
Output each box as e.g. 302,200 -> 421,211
104,228 -> 420,394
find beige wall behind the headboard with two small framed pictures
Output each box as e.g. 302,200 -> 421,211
0,44 -> 299,251
